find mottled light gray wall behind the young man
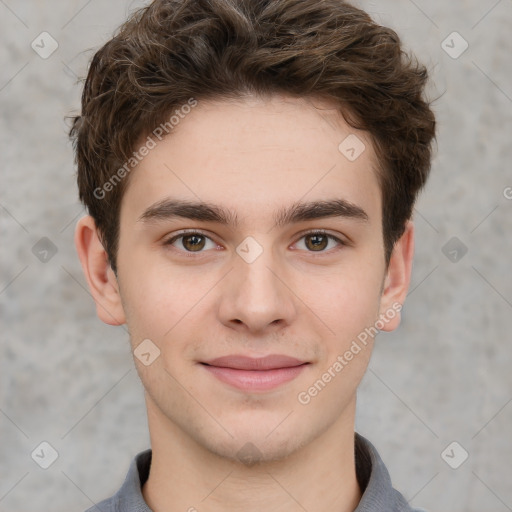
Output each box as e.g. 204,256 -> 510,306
0,0 -> 512,512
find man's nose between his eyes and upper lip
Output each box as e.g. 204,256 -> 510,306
218,245 -> 297,334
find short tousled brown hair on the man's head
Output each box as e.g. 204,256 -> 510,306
70,0 -> 436,271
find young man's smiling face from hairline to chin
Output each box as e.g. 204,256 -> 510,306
77,96 -> 412,460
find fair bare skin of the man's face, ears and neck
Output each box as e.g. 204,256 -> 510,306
75,95 -> 414,512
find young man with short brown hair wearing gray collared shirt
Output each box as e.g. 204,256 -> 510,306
71,0 -> 435,512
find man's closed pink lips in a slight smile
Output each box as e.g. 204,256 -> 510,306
201,354 -> 310,392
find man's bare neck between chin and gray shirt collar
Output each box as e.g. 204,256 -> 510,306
142,399 -> 361,512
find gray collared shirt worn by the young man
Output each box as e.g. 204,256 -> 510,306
86,432 -> 424,512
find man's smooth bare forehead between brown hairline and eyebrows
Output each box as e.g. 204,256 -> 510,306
121,96 -> 381,226
